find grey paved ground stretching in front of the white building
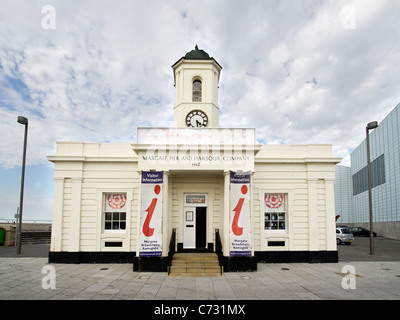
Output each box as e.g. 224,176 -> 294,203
0,238 -> 400,302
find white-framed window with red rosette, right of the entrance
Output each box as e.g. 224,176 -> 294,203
264,193 -> 287,230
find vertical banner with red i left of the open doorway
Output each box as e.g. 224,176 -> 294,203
139,171 -> 163,257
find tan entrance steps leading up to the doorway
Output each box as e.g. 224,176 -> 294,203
169,253 -> 221,277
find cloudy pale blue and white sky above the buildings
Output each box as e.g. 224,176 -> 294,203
0,0 -> 400,219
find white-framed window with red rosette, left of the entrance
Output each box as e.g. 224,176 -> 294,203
104,193 -> 126,230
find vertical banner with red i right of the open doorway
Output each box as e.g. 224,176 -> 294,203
230,171 -> 251,257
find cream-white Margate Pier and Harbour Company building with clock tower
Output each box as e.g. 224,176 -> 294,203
48,46 -> 340,272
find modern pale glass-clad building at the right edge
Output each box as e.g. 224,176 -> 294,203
335,104 -> 400,239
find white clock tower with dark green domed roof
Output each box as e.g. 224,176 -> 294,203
172,45 -> 222,128
